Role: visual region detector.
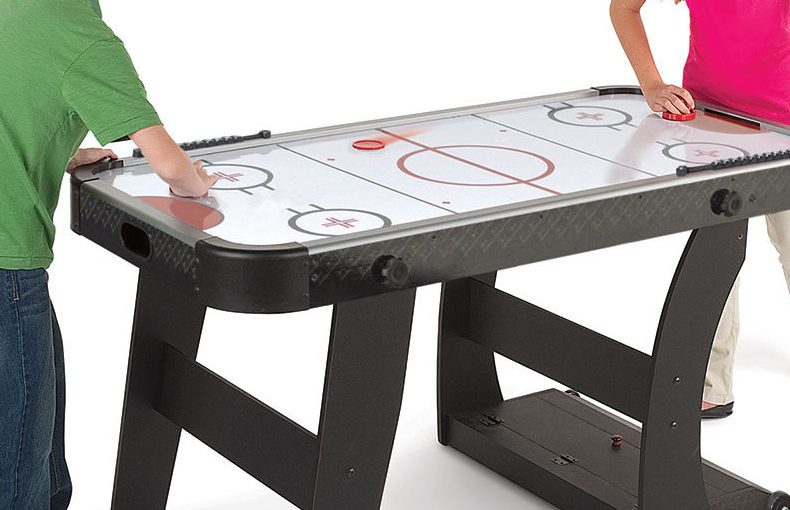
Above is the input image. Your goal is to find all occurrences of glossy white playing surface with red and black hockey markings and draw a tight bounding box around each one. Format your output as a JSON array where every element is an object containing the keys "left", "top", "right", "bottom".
[{"left": 102, "top": 95, "right": 790, "bottom": 249}]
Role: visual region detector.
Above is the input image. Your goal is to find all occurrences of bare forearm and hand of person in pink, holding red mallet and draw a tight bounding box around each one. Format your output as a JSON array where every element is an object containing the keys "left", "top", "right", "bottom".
[{"left": 609, "top": 0, "right": 694, "bottom": 113}]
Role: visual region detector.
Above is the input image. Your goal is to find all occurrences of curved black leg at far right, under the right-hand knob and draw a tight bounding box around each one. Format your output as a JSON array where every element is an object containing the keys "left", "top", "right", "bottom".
[{"left": 639, "top": 220, "right": 748, "bottom": 510}]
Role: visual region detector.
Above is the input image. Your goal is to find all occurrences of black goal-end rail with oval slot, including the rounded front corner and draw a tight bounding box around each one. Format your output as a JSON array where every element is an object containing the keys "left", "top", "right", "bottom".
[{"left": 71, "top": 163, "right": 309, "bottom": 313}]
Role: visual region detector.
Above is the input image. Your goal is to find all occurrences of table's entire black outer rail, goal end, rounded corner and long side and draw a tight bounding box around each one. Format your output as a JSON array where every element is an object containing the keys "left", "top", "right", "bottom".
[{"left": 72, "top": 157, "right": 790, "bottom": 313}]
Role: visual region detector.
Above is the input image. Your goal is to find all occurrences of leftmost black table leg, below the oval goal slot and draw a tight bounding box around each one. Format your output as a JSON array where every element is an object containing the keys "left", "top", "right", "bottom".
[{"left": 112, "top": 271, "right": 206, "bottom": 510}]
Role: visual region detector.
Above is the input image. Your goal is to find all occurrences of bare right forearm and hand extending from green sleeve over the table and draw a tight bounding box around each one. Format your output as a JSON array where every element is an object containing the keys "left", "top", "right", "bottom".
[{"left": 129, "top": 125, "right": 219, "bottom": 197}]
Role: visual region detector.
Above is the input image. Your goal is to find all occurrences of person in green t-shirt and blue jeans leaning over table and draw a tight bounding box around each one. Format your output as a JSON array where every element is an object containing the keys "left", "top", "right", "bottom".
[{"left": 0, "top": 0, "right": 217, "bottom": 504}]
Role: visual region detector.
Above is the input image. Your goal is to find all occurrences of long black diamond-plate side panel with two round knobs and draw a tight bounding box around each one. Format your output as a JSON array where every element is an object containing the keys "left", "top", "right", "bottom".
[{"left": 310, "top": 161, "right": 790, "bottom": 306}]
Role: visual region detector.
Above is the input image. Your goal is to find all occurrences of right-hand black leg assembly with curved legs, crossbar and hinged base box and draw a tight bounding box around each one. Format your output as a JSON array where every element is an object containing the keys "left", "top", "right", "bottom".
[{"left": 439, "top": 220, "right": 769, "bottom": 510}]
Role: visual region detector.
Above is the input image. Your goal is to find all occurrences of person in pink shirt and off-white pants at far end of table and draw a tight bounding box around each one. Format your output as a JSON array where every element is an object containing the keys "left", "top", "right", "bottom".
[{"left": 611, "top": 0, "right": 790, "bottom": 418}]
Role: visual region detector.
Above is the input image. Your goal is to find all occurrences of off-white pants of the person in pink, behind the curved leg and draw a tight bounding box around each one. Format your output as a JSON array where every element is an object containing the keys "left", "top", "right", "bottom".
[{"left": 703, "top": 211, "right": 790, "bottom": 405}]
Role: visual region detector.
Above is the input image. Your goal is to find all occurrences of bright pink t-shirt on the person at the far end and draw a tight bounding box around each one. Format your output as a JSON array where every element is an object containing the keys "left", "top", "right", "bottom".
[{"left": 683, "top": 0, "right": 790, "bottom": 125}]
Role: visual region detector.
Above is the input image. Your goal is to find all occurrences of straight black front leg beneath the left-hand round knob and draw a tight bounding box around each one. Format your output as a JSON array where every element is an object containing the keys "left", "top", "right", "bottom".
[{"left": 311, "top": 290, "right": 415, "bottom": 510}]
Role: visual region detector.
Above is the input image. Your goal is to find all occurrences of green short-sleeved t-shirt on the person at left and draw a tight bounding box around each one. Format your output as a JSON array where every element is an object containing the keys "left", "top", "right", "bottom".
[{"left": 0, "top": 0, "right": 160, "bottom": 269}]
